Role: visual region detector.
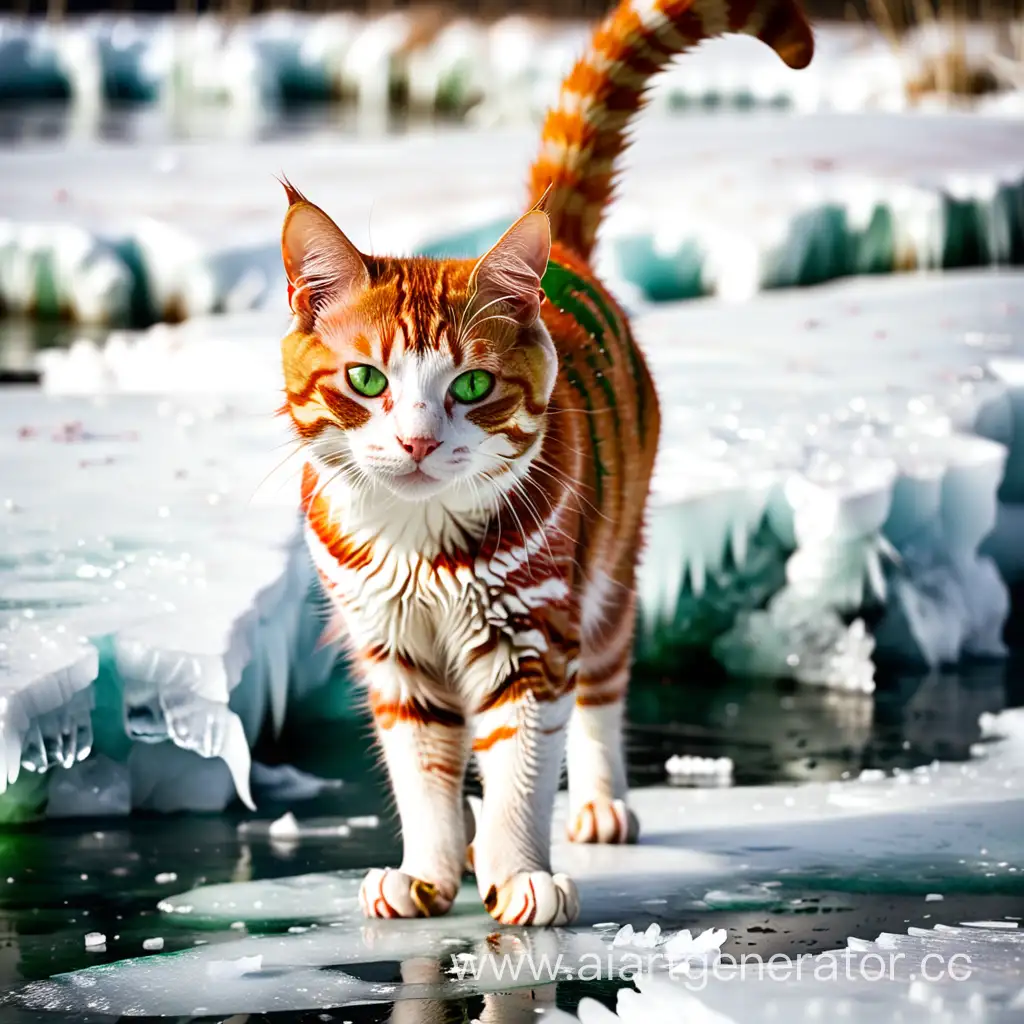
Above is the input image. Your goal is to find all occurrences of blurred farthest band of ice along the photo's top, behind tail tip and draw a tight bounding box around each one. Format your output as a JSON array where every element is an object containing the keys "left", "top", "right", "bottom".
[{"left": 0, "top": 11, "right": 1021, "bottom": 123}]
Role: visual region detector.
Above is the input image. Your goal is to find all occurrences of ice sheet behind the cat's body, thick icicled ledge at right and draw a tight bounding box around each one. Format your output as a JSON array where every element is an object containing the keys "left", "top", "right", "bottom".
[{"left": 36, "top": 271, "right": 1024, "bottom": 690}]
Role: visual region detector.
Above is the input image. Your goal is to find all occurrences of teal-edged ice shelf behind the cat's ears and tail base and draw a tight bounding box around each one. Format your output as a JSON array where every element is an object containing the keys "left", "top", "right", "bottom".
[{"left": 0, "top": 111, "right": 1024, "bottom": 325}]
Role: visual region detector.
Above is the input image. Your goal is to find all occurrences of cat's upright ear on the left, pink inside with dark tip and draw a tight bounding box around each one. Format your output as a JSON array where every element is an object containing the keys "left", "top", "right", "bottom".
[{"left": 281, "top": 180, "right": 370, "bottom": 314}]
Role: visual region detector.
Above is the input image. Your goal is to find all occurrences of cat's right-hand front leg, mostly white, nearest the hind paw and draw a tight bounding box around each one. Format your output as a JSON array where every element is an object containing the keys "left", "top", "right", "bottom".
[{"left": 473, "top": 657, "right": 580, "bottom": 926}]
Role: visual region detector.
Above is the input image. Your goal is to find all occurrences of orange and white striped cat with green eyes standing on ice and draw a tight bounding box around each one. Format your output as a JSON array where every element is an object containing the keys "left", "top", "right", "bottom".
[{"left": 282, "top": 0, "right": 813, "bottom": 926}]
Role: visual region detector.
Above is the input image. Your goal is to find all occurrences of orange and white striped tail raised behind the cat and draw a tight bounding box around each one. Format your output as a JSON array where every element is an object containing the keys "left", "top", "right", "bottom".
[{"left": 529, "top": 0, "right": 814, "bottom": 259}]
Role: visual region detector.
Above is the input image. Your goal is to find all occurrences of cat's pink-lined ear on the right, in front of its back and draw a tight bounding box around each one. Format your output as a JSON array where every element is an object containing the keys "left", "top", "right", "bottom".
[{"left": 470, "top": 209, "right": 551, "bottom": 327}]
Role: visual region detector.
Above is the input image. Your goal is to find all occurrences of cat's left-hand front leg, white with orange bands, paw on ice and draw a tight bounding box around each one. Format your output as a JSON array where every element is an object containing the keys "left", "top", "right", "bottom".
[{"left": 360, "top": 657, "right": 469, "bottom": 918}]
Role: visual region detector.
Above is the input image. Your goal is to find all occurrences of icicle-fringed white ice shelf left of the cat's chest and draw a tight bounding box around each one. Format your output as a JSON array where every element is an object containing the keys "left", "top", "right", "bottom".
[{"left": 0, "top": 376, "right": 330, "bottom": 815}]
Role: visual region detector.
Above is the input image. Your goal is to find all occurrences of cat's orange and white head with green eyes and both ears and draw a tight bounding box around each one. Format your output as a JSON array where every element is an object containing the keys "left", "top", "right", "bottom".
[{"left": 282, "top": 184, "right": 557, "bottom": 501}]
